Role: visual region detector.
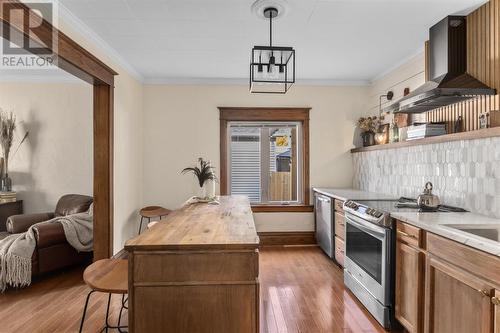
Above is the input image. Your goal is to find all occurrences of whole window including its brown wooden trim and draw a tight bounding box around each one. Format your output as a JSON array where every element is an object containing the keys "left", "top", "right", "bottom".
[{"left": 220, "top": 108, "right": 309, "bottom": 208}]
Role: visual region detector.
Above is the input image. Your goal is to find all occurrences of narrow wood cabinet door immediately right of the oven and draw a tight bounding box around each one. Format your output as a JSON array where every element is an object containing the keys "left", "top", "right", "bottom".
[{"left": 396, "top": 241, "right": 425, "bottom": 333}]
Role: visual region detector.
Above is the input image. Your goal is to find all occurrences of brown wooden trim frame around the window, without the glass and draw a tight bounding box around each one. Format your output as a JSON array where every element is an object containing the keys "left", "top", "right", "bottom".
[{"left": 219, "top": 107, "right": 313, "bottom": 213}]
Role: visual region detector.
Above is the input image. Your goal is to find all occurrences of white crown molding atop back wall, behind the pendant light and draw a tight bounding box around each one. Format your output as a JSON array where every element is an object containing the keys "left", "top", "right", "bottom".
[{"left": 144, "top": 77, "right": 370, "bottom": 86}]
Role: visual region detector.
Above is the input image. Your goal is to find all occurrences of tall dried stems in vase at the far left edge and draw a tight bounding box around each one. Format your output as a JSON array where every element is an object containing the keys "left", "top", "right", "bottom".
[{"left": 0, "top": 109, "right": 28, "bottom": 192}]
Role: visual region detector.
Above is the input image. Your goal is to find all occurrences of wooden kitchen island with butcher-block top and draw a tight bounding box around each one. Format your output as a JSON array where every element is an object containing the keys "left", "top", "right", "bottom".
[{"left": 125, "top": 196, "right": 259, "bottom": 333}]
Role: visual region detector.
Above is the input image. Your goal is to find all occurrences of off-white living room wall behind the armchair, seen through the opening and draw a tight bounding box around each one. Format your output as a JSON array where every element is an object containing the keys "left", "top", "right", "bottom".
[{"left": 0, "top": 82, "right": 93, "bottom": 213}]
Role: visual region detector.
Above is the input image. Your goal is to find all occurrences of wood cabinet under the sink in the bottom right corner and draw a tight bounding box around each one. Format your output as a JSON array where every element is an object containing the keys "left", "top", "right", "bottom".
[{"left": 425, "top": 234, "right": 500, "bottom": 333}]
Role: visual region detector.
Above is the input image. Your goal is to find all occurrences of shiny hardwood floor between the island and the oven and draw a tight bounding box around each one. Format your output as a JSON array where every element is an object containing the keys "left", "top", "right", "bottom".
[{"left": 259, "top": 247, "right": 392, "bottom": 333}]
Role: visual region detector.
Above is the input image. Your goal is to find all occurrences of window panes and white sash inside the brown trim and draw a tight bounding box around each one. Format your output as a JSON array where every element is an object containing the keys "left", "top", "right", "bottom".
[{"left": 228, "top": 121, "right": 302, "bottom": 203}]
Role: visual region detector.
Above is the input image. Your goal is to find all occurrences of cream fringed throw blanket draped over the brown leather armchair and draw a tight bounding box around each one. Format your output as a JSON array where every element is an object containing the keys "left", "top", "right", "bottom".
[{"left": 0, "top": 209, "right": 94, "bottom": 292}]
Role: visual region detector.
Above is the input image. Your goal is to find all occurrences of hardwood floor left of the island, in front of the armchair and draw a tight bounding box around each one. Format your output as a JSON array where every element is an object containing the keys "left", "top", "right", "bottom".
[{"left": 0, "top": 268, "right": 127, "bottom": 333}]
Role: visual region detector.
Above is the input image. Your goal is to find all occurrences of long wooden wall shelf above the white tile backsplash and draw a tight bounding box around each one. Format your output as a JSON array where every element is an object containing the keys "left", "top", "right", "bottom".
[{"left": 351, "top": 127, "right": 500, "bottom": 153}]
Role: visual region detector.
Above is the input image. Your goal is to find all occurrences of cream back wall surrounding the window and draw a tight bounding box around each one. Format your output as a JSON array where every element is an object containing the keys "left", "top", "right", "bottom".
[{"left": 144, "top": 85, "right": 367, "bottom": 231}]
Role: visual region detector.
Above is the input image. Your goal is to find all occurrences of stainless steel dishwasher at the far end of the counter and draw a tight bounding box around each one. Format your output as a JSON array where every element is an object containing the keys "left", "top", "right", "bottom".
[{"left": 314, "top": 193, "right": 335, "bottom": 259}]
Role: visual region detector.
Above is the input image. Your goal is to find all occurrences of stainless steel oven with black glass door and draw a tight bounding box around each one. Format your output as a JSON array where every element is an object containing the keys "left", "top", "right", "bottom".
[{"left": 344, "top": 201, "right": 395, "bottom": 328}]
